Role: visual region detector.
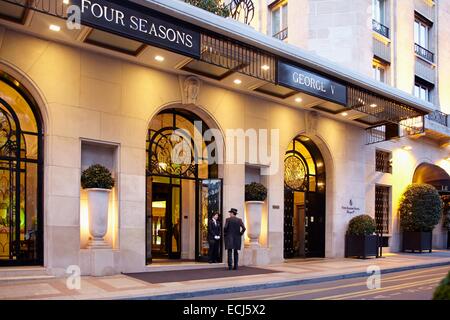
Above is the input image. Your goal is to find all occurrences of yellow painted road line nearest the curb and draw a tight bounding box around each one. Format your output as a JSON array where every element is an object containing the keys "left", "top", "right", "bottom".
[{"left": 228, "top": 266, "right": 449, "bottom": 300}]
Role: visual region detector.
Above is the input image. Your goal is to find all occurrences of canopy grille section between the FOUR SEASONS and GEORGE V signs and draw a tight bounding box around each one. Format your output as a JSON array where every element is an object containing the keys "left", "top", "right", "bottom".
[{"left": 200, "top": 34, "right": 276, "bottom": 83}]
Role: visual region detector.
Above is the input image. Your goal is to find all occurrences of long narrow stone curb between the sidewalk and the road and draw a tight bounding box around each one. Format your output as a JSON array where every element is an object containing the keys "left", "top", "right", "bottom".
[{"left": 124, "top": 261, "right": 450, "bottom": 300}]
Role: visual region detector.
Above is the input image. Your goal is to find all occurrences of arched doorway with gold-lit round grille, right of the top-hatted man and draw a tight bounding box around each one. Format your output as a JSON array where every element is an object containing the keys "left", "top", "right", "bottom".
[{"left": 284, "top": 136, "right": 325, "bottom": 259}]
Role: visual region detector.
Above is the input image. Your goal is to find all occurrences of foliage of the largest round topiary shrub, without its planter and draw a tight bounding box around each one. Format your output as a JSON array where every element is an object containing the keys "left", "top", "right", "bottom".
[{"left": 398, "top": 183, "right": 443, "bottom": 232}]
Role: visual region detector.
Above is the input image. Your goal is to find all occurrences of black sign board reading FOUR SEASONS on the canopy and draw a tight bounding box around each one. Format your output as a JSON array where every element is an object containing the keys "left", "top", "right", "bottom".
[{"left": 73, "top": 0, "right": 200, "bottom": 59}]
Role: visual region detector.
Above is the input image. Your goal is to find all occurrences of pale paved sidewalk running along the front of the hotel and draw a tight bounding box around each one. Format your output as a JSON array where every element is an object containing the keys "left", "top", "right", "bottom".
[{"left": 0, "top": 251, "right": 450, "bottom": 300}]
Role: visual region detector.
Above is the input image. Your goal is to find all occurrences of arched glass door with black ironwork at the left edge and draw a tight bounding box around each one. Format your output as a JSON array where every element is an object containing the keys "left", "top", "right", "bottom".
[{"left": 0, "top": 72, "right": 43, "bottom": 265}]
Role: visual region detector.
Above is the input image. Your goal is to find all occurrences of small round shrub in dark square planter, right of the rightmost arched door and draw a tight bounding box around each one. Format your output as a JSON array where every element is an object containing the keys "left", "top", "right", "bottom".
[{"left": 345, "top": 214, "right": 378, "bottom": 259}]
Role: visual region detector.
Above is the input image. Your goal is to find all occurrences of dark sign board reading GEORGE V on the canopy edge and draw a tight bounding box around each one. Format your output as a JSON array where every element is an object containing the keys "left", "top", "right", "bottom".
[{"left": 278, "top": 61, "right": 347, "bottom": 106}]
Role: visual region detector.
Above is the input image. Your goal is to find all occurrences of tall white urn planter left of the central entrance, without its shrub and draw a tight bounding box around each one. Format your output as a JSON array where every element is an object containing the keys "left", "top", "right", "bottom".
[{"left": 86, "top": 189, "right": 111, "bottom": 249}]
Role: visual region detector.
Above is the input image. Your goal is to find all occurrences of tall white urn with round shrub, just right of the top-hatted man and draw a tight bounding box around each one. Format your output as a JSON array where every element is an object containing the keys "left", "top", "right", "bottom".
[{"left": 245, "top": 182, "right": 267, "bottom": 246}]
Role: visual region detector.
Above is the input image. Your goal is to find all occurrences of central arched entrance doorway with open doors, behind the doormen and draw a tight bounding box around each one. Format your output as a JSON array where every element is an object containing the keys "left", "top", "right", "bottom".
[{"left": 146, "top": 109, "right": 222, "bottom": 263}]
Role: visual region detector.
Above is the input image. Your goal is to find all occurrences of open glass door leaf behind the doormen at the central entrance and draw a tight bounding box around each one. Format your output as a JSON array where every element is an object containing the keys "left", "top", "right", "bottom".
[{"left": 195, "top": 179, "right": 223, "bottom": 262}]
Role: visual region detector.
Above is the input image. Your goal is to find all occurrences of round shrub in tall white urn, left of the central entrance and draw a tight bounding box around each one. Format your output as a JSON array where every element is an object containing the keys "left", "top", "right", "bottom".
[{"left": 81, "top": 164, "right": 114, "bottom": 248}]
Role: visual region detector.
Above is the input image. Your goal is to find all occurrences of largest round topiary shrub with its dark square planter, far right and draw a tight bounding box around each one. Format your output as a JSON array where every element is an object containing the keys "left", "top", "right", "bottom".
[{"left": 398, "top": 183, "right": 443, "bottom": 252}]
